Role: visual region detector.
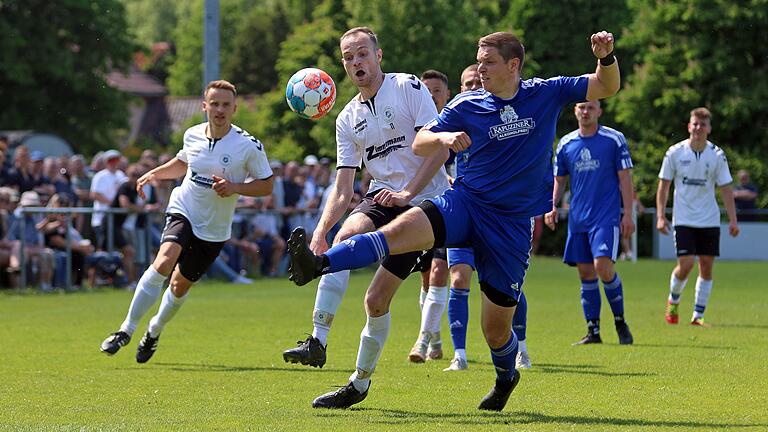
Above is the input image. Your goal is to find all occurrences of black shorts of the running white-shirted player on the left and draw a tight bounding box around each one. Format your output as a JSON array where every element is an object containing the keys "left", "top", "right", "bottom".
[{"left": 160, "top": 213, "right": 226, "bottom": 282}]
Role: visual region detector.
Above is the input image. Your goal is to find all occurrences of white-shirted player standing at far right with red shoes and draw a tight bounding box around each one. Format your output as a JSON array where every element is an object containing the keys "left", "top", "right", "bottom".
[{"left": 656, "top": 108, "right": 739, "bottom": 326}]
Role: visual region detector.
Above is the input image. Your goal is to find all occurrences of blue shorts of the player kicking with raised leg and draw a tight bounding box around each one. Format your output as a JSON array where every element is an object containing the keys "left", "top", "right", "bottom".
[{"left": 430, "top": 189, "right": 533, "bottom": 302}]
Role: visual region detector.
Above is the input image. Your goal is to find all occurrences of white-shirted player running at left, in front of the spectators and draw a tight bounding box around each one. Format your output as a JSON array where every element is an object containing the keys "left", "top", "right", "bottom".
[{"left": 101, "top": 80, "right": 273, "bottom": 363}]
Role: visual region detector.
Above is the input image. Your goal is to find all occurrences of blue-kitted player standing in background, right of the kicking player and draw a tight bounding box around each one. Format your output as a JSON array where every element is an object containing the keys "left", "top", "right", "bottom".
[{"left": 544, "top": 101, "right": 635, "bottom": 345}]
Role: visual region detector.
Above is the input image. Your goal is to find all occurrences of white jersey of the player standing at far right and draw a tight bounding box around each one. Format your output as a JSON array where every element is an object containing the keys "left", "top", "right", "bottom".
[{"left": 659, "top": 139, "right": 733, "bottom": 228}]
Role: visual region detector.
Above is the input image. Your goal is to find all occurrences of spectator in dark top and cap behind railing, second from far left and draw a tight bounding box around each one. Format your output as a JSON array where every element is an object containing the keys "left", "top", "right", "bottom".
[{"left": 41, "top": 194, "right": 95, "bottom": 288}]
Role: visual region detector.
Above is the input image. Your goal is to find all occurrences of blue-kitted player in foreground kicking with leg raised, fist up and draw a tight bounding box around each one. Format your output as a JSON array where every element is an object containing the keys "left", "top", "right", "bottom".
[{"left": 288, "top": 32, "right": 620, "bottom": 411}]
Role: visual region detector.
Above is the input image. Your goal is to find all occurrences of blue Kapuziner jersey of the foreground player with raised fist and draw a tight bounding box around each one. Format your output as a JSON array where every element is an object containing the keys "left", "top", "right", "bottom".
[{"left": 425, "top": 76, "right": 588, "bottom": 217}]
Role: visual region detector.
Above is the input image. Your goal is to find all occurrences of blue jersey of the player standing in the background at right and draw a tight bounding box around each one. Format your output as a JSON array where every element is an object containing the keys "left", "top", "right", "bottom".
[{"left": 555, "top": 125, "right": 632, "bottom": 232}]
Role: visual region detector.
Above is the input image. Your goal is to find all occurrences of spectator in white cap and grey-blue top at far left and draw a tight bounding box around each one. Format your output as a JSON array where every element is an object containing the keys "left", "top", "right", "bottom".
[{"left": 8, "top": 191, "right": 54, "bottom": 292}]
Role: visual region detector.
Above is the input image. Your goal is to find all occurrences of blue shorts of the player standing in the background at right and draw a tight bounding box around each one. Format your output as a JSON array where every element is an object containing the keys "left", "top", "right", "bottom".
[{"left": 563, "top": 226, "right": 619, "bottom": 265}]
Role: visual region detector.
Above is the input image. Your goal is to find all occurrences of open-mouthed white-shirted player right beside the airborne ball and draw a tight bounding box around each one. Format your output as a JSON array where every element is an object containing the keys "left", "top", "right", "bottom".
[{"left": 283, "top": 27, "right": 448, "bottom": 407}]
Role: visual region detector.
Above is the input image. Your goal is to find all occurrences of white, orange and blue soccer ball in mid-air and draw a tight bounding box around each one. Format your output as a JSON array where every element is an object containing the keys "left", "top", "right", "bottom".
[{"left": 285, "top": 68, "right": 336, "bottom": 120}]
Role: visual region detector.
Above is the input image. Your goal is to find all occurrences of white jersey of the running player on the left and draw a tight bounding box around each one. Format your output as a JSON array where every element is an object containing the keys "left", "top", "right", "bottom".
[{"left": 166, "top": 123, "right": 272, "bottom": 242}]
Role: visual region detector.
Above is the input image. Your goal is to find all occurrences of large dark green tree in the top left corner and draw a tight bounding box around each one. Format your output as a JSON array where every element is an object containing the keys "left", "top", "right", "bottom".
[{"left": 0, "top": 0, "right": 135, "bottom": 153}]
